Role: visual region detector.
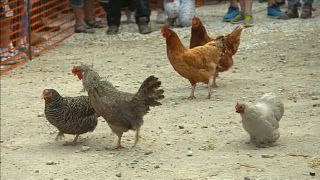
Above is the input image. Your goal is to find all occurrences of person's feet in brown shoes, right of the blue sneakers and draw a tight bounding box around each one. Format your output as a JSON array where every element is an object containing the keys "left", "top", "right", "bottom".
[{"left": 286, "top": 0, "right": 313, "bottom": 19}]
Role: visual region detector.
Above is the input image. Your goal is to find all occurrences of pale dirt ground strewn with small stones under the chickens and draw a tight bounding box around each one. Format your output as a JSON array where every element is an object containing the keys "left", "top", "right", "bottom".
[{"left": 1, "top": 1, "right": 320, "bottom": 180}]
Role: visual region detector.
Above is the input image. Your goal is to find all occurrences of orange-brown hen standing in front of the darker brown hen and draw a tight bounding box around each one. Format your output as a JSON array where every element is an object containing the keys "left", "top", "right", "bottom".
[{"left": 161, "top": 26, "right": 222, "bottom": 99}]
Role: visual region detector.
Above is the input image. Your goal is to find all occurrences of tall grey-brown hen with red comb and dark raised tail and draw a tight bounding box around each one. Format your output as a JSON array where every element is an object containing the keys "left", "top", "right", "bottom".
[{"left": 72, "top": 65, "right": 164, "bottom": 149}]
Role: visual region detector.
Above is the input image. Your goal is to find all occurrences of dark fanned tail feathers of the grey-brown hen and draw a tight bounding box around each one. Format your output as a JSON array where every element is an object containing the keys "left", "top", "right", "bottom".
[{"left": 137, "top": 76, "right": 164, "bottom": 106}]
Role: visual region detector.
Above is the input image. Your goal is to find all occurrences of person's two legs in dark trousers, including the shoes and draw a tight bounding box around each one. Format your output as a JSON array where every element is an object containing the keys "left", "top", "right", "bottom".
[{"left": 100, "top": 0, "right": 151, "bottom": 35}]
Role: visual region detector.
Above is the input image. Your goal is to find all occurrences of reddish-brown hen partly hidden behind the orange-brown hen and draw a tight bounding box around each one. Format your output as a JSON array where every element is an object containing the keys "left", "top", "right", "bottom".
[{"left": 190, "top": 16, "right": 243, "bottom": 74}]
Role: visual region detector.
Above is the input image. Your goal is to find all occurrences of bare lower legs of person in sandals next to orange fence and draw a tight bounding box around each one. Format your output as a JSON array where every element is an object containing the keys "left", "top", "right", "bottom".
[{"left": 70, "top": 0, "right": 104, "bottom": 33}]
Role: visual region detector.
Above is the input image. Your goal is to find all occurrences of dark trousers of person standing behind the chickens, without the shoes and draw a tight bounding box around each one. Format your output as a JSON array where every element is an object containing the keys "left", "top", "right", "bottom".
[{"left": 100, "top": 0, "right": 151, "bottom": 27}]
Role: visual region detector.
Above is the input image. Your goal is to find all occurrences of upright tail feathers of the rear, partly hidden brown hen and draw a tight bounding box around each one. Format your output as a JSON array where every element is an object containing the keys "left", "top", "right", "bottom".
[{"left": 224, "top": 26, "right": 243, "bottom": 55}]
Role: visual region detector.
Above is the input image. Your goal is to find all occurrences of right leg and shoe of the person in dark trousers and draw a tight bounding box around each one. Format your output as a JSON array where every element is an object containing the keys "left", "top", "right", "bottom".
[{"left": 135, "top": 0, "right": 151, "bottom": 34}]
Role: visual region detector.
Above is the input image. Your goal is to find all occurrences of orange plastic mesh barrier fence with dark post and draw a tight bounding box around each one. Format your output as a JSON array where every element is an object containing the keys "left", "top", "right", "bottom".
[{"left": 0, "top": 0, "right": 203, "bottom": 75}]
